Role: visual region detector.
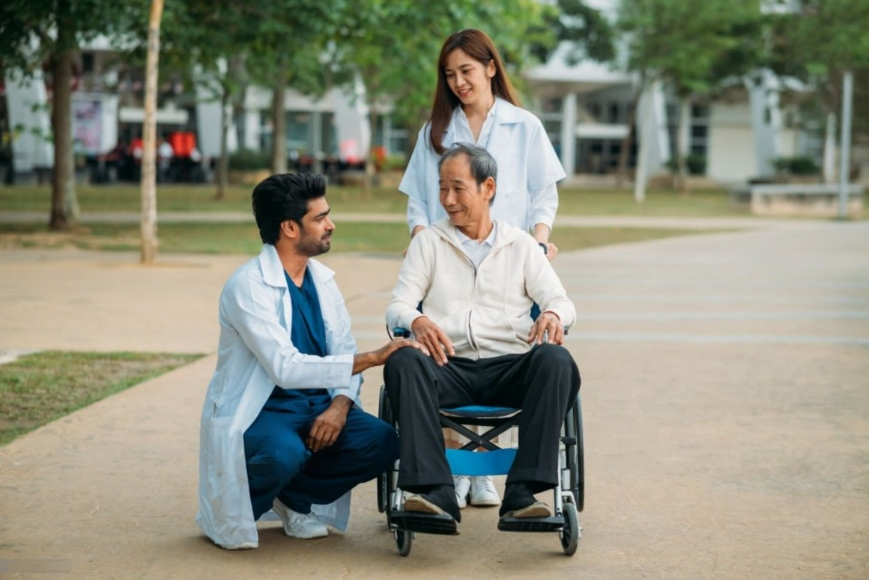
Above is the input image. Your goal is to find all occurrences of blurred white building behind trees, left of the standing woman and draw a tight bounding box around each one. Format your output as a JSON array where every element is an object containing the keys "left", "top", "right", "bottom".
[{"left": 3, "top": 38, "right": 392, "bottom": 176}]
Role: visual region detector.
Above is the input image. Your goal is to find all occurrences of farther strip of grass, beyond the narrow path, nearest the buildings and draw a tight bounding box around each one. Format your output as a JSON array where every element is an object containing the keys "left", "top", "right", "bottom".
[{"left": 0, "top": 185, "right": 768, "bottom": 220}]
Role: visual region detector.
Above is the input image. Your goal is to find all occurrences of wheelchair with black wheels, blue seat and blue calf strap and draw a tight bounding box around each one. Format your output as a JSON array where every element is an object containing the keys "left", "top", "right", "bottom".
[{"left": 377, "top": 376, "right": 585, "bottom": 556}]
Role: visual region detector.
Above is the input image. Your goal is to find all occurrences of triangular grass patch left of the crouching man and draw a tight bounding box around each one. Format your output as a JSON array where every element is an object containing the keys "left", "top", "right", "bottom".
[{"left": 0, "top": 351, "right": 203, "bottom": 445}]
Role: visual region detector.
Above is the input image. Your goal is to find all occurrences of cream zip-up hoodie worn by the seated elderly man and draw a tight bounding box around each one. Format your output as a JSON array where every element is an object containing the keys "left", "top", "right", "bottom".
[{"left": 386, "top": 218, "right": 576, "bottom": 359}]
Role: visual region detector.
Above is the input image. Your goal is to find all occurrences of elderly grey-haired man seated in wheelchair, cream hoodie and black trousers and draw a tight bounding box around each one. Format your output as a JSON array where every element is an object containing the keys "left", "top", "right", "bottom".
[{"left": 384, "top": 144, "right": 580, "bottom": 549}]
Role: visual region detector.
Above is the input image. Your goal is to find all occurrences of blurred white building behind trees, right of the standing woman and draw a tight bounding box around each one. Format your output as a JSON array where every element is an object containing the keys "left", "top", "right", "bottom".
[{"left": 525, "top": 0, "right": 824, "bottom": 184}]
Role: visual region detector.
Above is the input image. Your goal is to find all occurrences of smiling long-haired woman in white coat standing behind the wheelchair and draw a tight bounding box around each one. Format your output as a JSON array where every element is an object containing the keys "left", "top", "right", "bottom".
[{"left": 398, "top": 29, "right": 565, "bottom": 507}]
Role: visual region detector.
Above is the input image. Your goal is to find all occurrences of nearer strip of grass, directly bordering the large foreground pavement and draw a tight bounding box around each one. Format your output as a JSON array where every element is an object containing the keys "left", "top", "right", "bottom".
[{"left": 0, "top": 223, "right": 724, "bottom": 255}]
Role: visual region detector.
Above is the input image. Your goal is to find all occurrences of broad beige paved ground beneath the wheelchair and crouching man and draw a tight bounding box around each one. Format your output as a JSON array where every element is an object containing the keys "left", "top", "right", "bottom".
[{"left": 0, "top": 221, "right": 869, "bottom": 580}]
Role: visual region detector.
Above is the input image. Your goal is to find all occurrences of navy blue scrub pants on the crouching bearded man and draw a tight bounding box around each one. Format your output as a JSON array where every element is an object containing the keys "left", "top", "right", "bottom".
[{"left": 244, "top": 391, "right": 398, "bottom": 520}]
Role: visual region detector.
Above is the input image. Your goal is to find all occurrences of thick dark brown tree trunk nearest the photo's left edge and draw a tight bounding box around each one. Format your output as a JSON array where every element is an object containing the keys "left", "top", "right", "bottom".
[{"left": 48, "top": 43, "right": 79, "bottom": 230}]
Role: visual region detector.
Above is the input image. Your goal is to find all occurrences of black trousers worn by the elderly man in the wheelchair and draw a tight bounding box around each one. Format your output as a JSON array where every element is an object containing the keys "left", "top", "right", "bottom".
[{"left": 383, "top": 344, "right": 580, "bottom": 493}]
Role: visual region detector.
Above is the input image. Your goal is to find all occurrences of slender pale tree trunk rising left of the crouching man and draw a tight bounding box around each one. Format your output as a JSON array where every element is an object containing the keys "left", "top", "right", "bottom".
[{"left": 141, "top": 0, "right": 163, "bottom": 264}]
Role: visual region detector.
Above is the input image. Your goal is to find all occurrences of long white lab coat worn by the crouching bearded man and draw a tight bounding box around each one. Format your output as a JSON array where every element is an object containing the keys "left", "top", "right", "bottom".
[{"left": 196, "top": 244, "right": 362, "bottom": 548}]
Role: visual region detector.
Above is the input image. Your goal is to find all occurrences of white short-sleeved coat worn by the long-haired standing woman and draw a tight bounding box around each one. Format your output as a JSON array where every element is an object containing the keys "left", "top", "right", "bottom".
[{"left": 398, "top": 98, "right": 566, "bottom": 232}]
